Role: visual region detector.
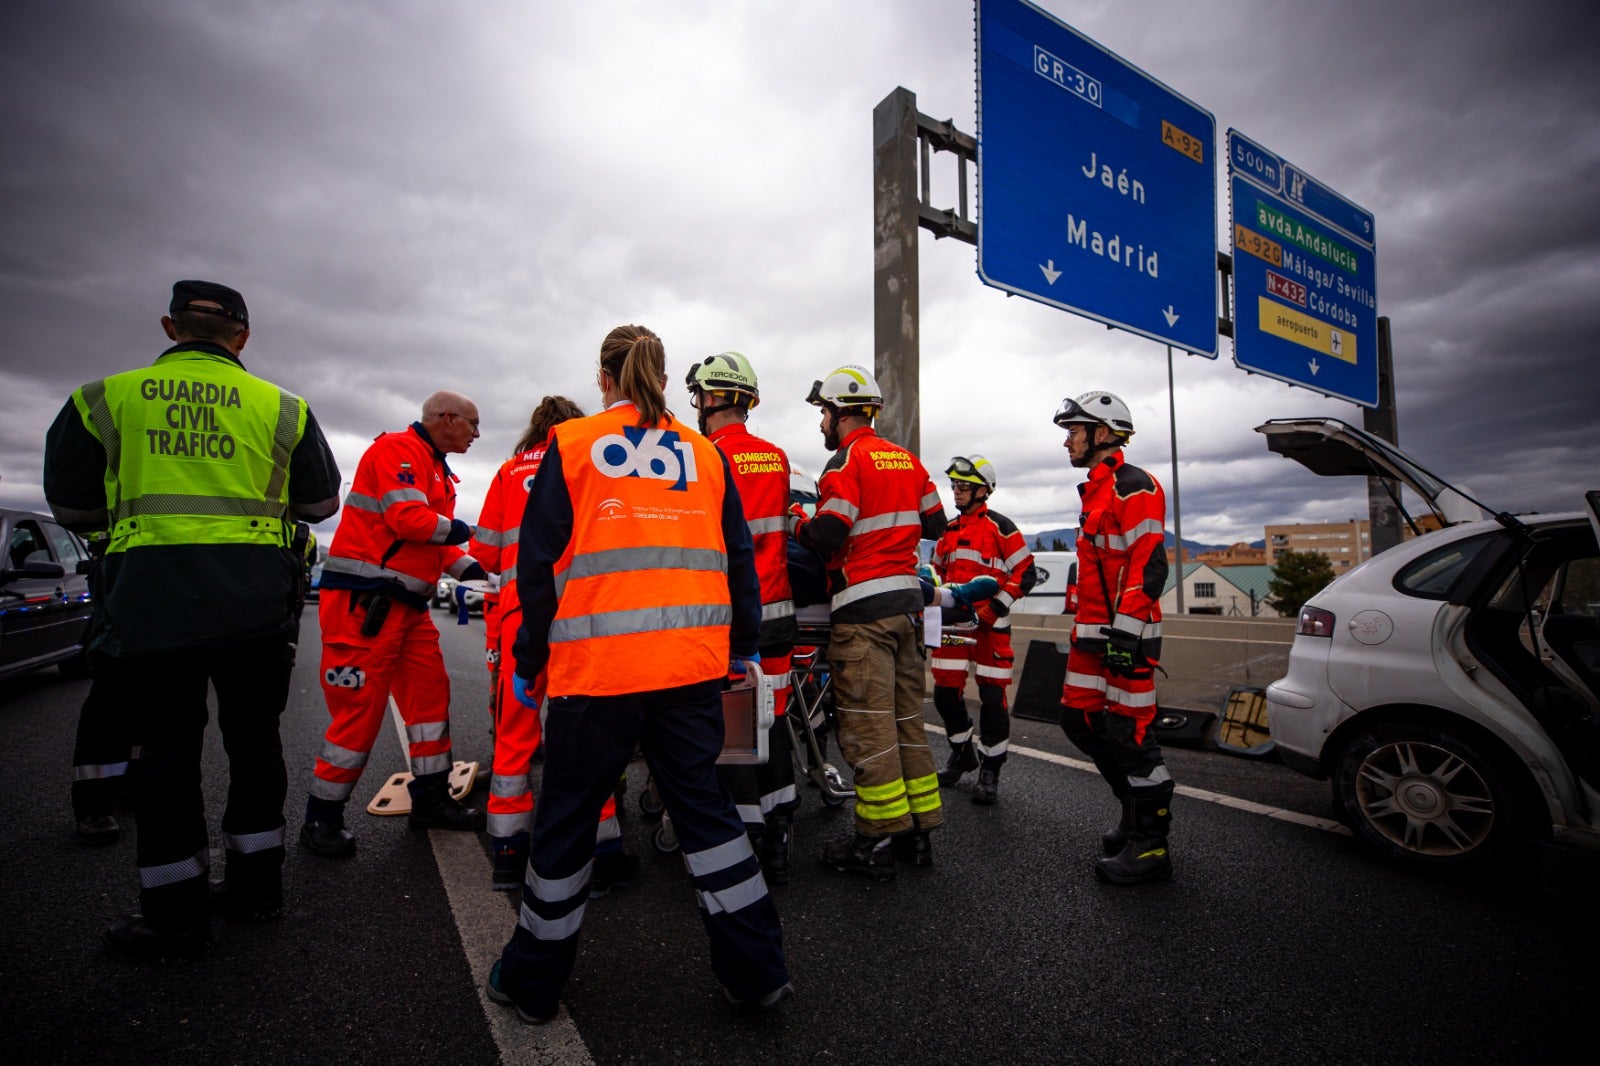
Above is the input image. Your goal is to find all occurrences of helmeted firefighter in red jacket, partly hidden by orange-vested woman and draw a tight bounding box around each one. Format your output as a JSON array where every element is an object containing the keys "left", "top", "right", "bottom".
[{"left": 686, "top": 352, "right": 800, "bottom": 885}]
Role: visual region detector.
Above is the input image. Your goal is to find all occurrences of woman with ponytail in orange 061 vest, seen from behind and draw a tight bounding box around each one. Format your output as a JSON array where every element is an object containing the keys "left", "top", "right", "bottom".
[{"left": 488, "top": 325, "right": 790, "bottom": 1024}]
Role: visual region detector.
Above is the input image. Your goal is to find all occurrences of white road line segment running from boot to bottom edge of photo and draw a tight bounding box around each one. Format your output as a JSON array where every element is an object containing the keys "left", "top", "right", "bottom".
[{"left": 427, "top": 829, "right": 595, "bottom": 1066}]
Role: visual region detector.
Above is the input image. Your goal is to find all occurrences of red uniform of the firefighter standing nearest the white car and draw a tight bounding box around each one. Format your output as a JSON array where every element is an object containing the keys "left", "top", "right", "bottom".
[{"left": 1061, "top": 448, "right": 1171, "bottom": 795}]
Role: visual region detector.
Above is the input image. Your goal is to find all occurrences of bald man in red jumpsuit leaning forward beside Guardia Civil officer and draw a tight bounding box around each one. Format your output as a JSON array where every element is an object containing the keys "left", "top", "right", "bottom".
[{"left": 301, "top": 392, "right": 488, "bottom": 858}]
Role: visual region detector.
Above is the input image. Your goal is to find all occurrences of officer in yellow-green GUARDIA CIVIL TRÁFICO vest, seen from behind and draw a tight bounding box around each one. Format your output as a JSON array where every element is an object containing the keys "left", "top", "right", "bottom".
[{"left": 45, "top": 282, "right": 339, "bottom": 959}]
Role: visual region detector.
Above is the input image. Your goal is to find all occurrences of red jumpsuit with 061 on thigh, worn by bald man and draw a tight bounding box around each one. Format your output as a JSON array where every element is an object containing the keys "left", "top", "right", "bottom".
[{"left": 310, "top": 423, "right": 474, "bottom": 802}]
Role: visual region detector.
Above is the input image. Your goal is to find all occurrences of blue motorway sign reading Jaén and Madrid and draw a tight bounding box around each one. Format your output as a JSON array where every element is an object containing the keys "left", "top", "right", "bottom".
[{"left": 978, "top": 0, "right": 1218, "bottom": 359}]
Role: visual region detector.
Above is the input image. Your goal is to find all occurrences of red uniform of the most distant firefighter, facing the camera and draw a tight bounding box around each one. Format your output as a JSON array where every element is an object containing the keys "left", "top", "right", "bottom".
[{"left": 930, "top": 503, "right": 1034, "bottom": 765}]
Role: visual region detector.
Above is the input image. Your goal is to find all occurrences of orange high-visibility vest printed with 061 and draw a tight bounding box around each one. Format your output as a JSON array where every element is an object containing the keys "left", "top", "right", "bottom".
[{"left": 547, "top": 405, "right": 733, "bottom": 696}]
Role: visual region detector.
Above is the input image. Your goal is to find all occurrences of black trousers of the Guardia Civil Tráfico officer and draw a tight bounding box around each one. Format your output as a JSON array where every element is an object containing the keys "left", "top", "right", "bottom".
[{"left": 120, "top": 637, "right": 293, "bottom": 930}]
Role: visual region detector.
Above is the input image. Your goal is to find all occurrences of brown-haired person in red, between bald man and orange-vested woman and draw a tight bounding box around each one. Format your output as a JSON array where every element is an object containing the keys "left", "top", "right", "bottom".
[{"left": 467, "top": 395, "right": 638, "bottom": 898}]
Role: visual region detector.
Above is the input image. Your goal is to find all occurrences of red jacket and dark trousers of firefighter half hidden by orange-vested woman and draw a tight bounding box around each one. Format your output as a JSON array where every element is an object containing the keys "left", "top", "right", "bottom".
[{"left": 709, "top": 423, "right": 800, "bottom": 829}]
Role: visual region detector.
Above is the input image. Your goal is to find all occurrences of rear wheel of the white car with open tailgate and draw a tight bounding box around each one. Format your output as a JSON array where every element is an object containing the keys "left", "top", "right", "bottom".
[{"left": 1333, "top": 725, "right": 1515, "bottom": 869}]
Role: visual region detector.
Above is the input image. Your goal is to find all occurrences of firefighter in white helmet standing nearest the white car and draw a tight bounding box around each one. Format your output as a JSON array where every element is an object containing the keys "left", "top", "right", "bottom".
[{"left": 1056, "top": 392, "right": 1173, "bottom": 885}]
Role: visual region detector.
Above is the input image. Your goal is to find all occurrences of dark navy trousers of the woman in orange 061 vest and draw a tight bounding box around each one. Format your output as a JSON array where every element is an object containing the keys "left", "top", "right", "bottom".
[{"left": 501, "top": 679, "right": 789, "bottom": 1015}]
